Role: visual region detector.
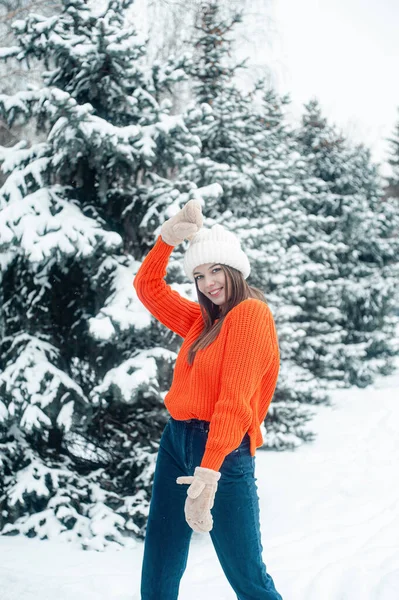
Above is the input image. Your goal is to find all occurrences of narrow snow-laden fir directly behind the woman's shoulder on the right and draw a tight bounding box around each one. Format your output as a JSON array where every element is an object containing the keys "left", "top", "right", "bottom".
[{"left": 236, "top": 85, "right": 334, "bottom": 449}]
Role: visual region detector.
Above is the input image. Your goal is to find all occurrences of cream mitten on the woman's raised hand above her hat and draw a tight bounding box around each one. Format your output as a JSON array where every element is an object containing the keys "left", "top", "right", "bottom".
[{"left": 161, "top": 200, "right": 203, "bottom": 246}]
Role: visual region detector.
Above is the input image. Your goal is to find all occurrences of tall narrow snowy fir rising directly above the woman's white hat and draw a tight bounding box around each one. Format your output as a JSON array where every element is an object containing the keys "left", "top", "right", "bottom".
[{"left": 186, "top": 0, "right": 268, "bottom": 220}]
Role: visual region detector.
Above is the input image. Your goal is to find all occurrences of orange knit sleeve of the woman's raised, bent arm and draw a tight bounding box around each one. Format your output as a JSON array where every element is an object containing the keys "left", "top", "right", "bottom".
[{"left": 133, "top": 236, "right": 201, "bottom": 338}]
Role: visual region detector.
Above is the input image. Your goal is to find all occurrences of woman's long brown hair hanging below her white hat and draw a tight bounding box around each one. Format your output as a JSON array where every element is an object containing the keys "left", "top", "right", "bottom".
[{"left": 187, "top": 263, "right": 267, "bottom": 365}]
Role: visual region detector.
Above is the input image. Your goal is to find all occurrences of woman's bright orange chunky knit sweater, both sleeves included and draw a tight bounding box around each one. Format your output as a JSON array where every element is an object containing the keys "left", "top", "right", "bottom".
[{"left": 133, "top": 236, "right": 280, "bottom": 471}]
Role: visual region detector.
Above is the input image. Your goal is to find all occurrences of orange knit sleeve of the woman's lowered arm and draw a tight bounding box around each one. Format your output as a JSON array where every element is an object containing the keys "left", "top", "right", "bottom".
[{"left": 201, "top": 299, "right": 280, "bottom": 471}]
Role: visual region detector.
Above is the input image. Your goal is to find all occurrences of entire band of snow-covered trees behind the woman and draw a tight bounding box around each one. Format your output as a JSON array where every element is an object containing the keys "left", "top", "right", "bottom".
[{"left": 0, "top": 0, "right": 399, "bottom": 576}]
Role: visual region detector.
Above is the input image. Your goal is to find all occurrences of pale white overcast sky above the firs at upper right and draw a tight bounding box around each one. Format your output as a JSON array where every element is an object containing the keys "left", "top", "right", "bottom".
[{"left": 258, "top": 0, "right": 399, "bottom": 172}]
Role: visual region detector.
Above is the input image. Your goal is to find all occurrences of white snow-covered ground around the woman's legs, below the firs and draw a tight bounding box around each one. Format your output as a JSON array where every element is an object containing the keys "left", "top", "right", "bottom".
[{"left": 0, "top": 360, "right": 399, "bottom": 600}]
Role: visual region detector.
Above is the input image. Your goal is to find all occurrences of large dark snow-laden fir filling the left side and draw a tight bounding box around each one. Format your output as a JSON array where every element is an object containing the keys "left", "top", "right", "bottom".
[{"left": 0, "top": 0, "right": 203, "bottom": 549}]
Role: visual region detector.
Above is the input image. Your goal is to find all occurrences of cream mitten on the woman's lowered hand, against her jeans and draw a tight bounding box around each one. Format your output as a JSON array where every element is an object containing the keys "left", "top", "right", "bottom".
[{"left": 176, "top": 467, "right": 221, "bottom": 533}]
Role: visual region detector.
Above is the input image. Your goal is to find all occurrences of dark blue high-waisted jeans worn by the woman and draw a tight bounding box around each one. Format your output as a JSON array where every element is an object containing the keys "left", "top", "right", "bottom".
[{"left": 141, "top": 418, "right": 282, "bottom": 600}]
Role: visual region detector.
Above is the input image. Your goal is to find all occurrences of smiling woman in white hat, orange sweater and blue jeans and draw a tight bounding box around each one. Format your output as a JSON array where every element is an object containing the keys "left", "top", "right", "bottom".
[{"left": 134, "top": 200, "right": 282, "bottom": 600}]
